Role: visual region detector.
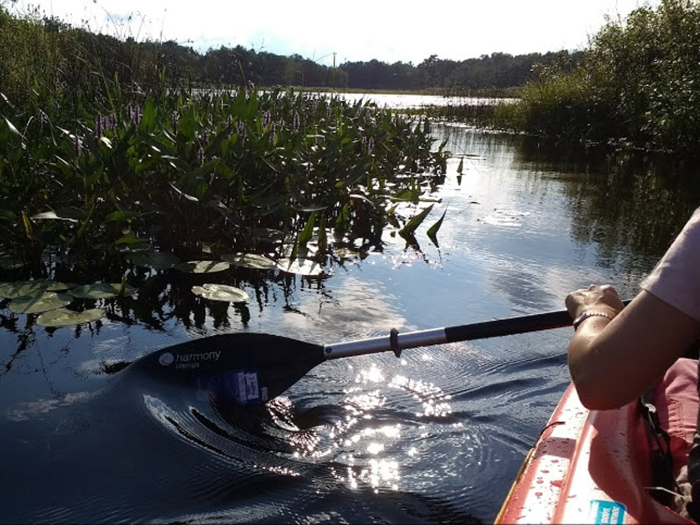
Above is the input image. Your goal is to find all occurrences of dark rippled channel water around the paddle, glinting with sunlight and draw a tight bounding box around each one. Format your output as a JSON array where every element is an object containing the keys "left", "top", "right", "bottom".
[{"left": 0, "top": 127, "right": 700, "bottom": 523}]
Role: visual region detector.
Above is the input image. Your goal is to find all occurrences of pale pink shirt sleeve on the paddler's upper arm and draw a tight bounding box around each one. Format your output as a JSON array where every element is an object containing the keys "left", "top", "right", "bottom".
[{"left": 641, "top": 208, "right": 700, "bottom": 321}]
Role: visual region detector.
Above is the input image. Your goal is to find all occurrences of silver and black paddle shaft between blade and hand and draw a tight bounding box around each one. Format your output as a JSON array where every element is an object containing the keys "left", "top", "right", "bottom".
[{"left": 323, "top": 300, "right": 630, "bottom": 359}]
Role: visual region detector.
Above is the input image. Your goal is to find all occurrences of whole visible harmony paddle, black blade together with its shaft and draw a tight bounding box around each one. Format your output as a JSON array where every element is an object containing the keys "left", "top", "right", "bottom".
[{"left": 129, "top": 301, "right": 629, "bottom": 406}]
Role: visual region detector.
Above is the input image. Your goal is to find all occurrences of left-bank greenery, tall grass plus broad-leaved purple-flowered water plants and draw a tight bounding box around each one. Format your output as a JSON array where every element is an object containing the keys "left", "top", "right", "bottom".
[{"left": 0, "top": 4, "right": 449, "bottom": 288}]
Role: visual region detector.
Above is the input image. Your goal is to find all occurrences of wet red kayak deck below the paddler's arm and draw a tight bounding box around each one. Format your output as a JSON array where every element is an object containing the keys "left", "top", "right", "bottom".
[{"left": 496, "top": 362, "right": 695, "bottom": 523}]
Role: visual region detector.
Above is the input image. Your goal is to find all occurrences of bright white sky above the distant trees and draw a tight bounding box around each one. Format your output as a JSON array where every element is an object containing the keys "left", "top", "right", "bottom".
[{"left": 9, "top": 0, "right": 660, "bottom": 65}]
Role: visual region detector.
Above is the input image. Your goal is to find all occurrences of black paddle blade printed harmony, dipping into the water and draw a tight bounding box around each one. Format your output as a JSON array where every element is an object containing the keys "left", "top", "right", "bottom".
[{"left": 128, "top": 333, "right": 324, "bottom": 406}]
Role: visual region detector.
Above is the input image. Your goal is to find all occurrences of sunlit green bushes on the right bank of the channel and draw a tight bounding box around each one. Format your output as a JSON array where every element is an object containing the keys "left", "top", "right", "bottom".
[{"left": 496, "top": 0, "right": 700, "bottom": 157}]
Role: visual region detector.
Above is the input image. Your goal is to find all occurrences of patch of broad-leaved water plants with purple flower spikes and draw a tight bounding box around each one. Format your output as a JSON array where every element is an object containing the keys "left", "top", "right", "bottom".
[{"left": 0, "top": 89, "right": 448, "bottom": 278}]
